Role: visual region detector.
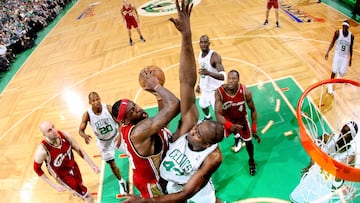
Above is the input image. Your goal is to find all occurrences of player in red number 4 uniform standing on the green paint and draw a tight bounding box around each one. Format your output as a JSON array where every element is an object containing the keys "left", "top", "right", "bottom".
[{"left": 215, "top": 70, "right": 261, "bottom": 176}]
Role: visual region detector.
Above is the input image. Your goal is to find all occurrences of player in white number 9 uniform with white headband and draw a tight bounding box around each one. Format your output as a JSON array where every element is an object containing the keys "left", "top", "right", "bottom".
[{"left": 325, "top": 20, "right": 355, "bottom": 94}]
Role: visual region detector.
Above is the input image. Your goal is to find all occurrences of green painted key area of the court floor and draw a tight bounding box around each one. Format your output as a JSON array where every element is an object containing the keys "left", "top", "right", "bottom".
[{"left": 98, "top": 77, "right": 360, "bottom": 203}]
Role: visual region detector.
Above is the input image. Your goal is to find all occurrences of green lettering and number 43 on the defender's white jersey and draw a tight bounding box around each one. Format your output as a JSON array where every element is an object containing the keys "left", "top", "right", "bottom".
[{"left": 163, "top": 149, "right": 192, "bottom": 176}]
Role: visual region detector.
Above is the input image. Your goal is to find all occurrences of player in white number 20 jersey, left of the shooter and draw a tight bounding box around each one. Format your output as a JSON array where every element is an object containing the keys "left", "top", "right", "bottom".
[{"left": 79, "top": 92, "right": 128, "bottom": 195}]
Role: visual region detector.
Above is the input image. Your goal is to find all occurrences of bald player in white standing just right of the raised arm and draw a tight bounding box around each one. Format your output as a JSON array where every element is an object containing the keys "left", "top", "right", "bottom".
[{"left": 196, "top": 35, "right": 226, "bottom": 120}]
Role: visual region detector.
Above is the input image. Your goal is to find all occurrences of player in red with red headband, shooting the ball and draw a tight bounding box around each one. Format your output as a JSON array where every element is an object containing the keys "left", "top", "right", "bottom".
[{"left": 112, "top": 69, "right": 180, "bottom": 198}]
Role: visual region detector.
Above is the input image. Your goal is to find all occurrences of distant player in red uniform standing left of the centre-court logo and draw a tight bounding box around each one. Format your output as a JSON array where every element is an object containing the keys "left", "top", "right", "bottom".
[{"left": 121, "top": 0, "right": 145, "bottom": 46}]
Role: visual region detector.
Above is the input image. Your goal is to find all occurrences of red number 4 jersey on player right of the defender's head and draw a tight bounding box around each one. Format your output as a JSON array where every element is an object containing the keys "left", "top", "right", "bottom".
[{"left": 218, "top": 84, "right": 247, "bottom": 124}]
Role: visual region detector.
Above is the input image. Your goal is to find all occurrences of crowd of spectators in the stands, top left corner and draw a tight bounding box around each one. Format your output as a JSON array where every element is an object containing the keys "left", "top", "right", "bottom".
[{"left": 0, "top": 0, "right": 71, "bottom": 72}]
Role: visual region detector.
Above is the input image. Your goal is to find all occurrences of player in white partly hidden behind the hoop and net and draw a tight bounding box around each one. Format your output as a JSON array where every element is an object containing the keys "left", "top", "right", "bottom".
[{"left": 290, "top": 121, "right": 360, "bottom": 203}]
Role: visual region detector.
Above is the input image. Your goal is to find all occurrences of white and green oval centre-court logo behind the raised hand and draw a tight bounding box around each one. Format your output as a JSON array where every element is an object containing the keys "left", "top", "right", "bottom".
[{"left": 137, "top": 0, "right": 201, "bottom": 16}]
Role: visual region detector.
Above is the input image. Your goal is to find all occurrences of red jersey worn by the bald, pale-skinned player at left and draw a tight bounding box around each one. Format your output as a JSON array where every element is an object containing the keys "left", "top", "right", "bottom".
[{"left": 41, "top": 131, "right": 75, "bottom": 177}]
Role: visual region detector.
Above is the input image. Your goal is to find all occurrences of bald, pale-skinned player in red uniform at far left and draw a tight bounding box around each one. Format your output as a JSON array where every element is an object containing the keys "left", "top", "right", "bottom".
[{"left": 34, "top": 121, "right": 100, "bottom": 202}]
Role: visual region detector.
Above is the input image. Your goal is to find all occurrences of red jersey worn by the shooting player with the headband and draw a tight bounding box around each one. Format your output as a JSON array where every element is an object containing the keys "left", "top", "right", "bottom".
[{"left": 121, "top": 125, "right": 171, "bottom": 198}]
